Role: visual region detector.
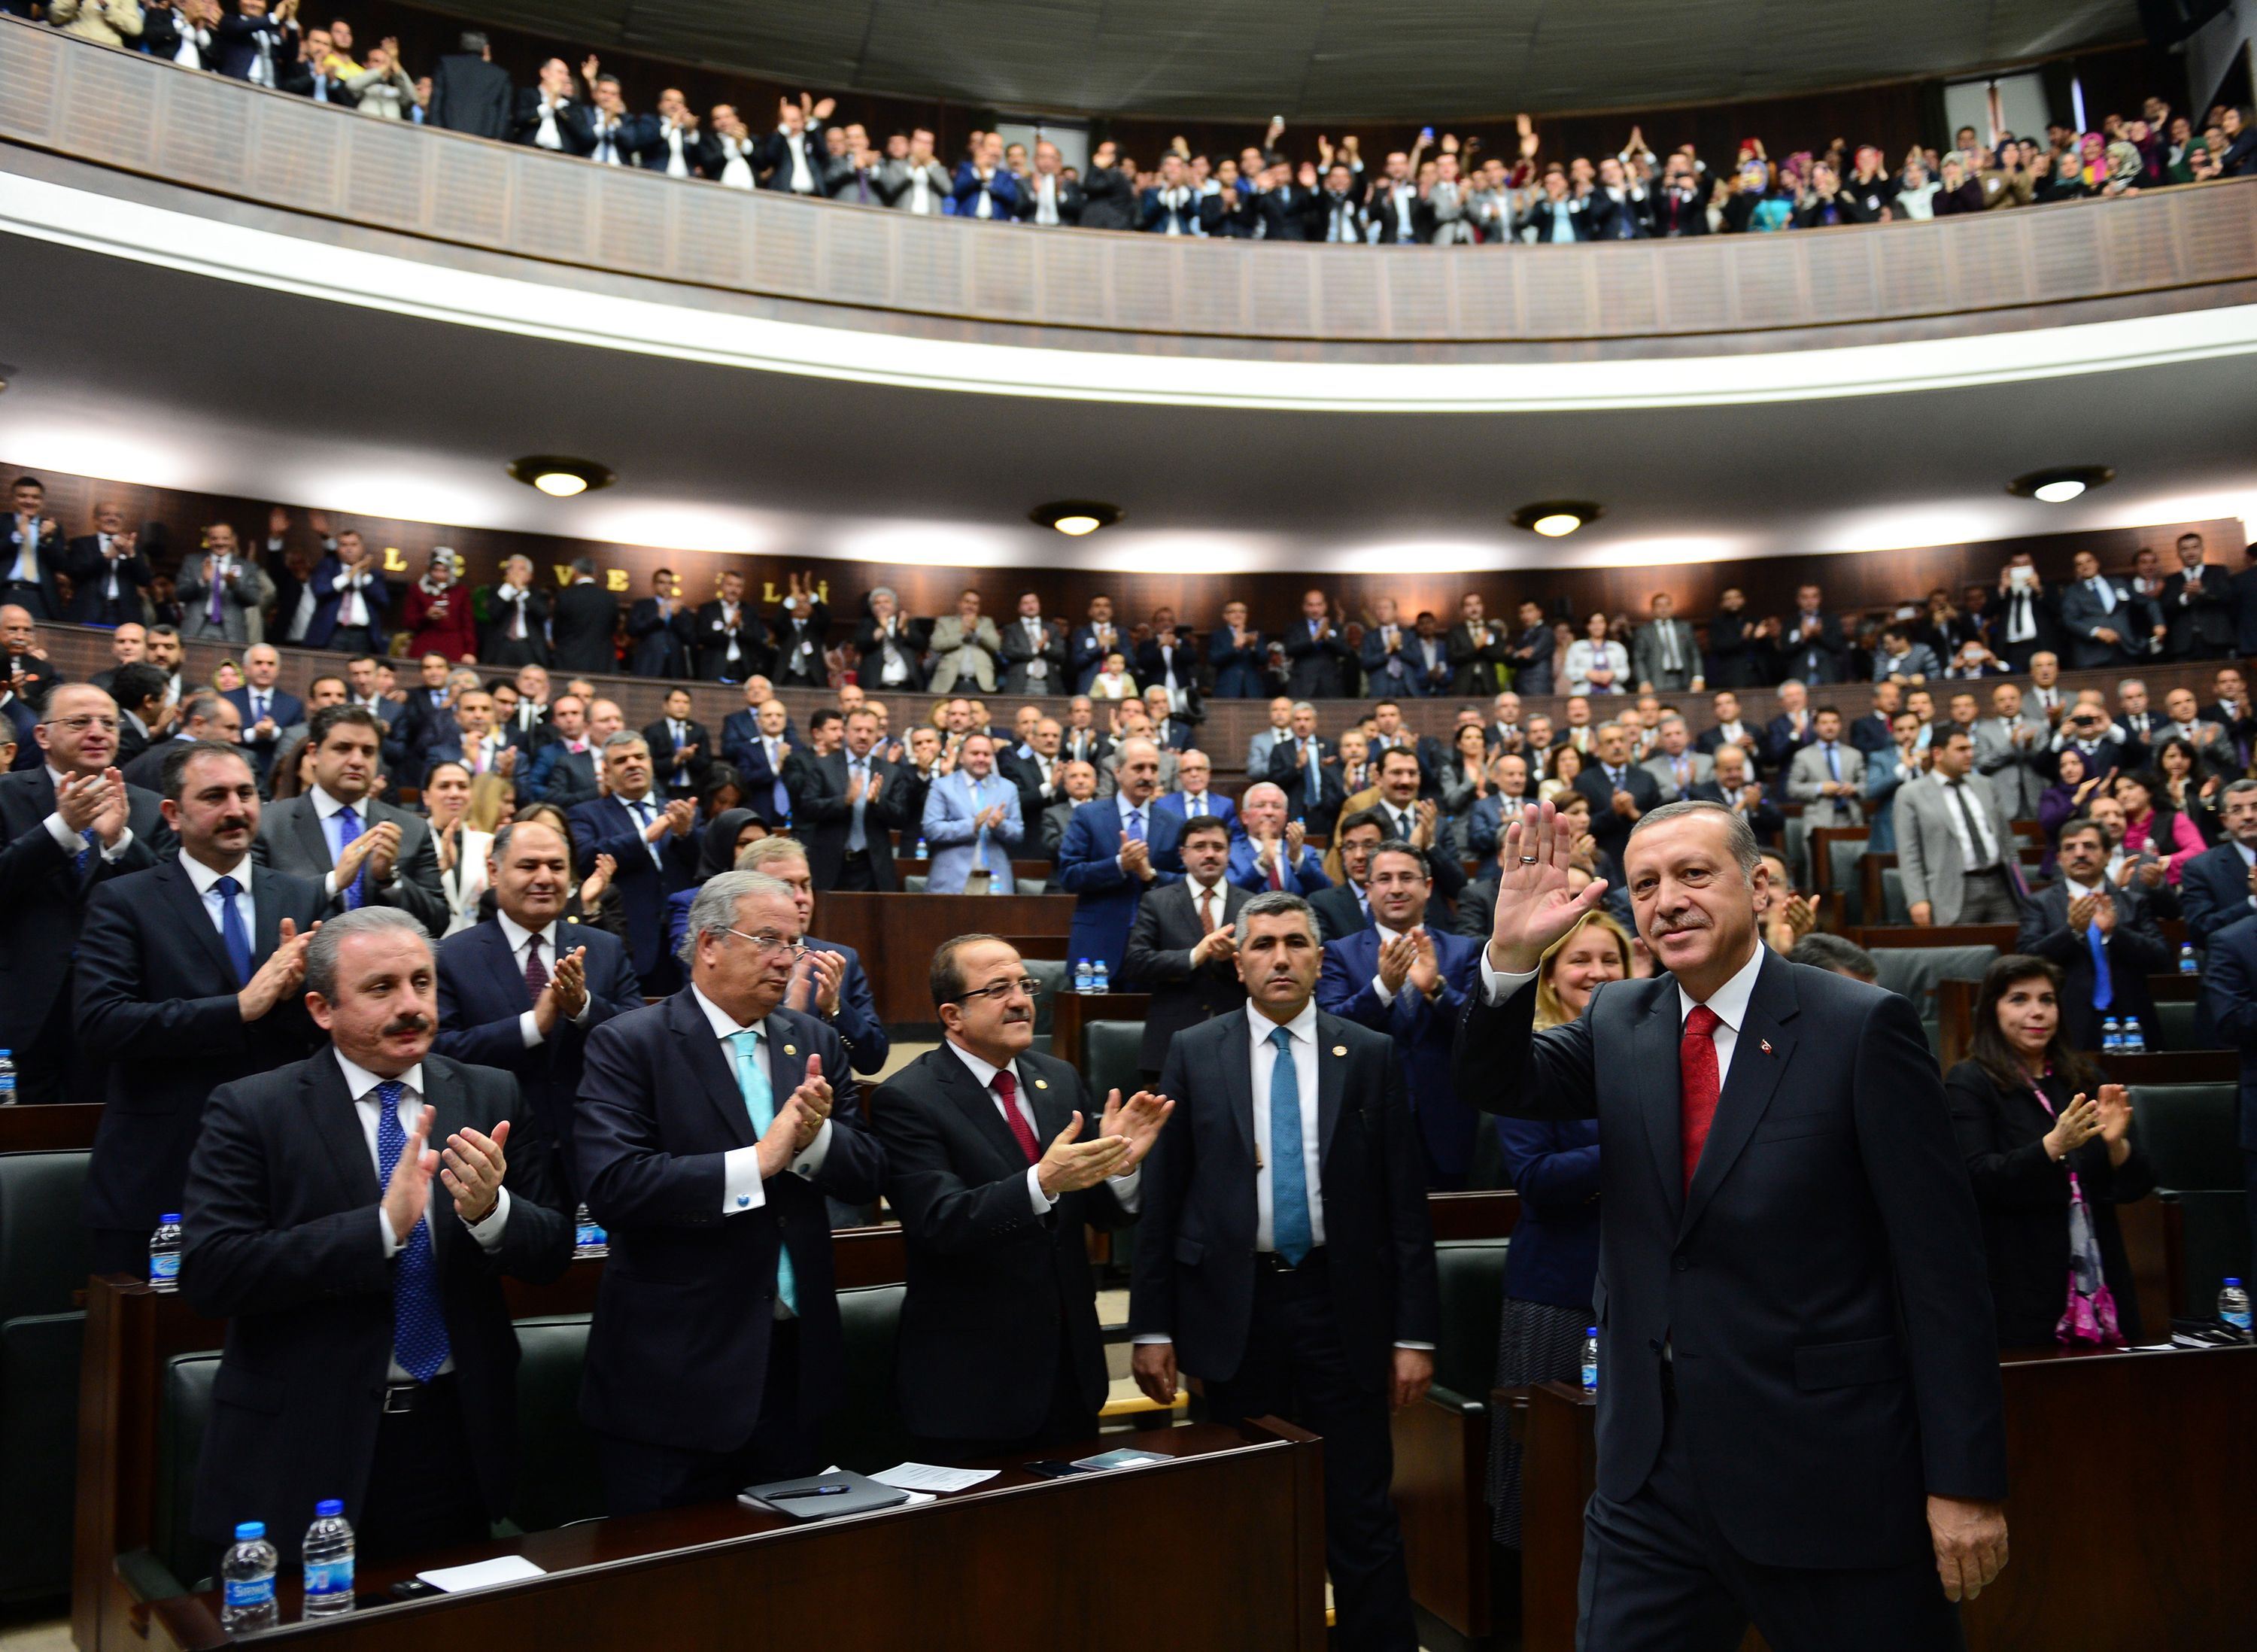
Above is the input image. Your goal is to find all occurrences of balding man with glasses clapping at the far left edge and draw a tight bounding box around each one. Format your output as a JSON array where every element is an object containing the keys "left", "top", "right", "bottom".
[{"left": 0, "top": 682, "right": 172, "bottom": 1101}]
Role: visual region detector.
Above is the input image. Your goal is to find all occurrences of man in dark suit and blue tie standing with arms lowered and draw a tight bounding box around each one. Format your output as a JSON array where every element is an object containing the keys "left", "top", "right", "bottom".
[{"left": 1128, "top": 891, "right": 1442, "bottom": 1652}]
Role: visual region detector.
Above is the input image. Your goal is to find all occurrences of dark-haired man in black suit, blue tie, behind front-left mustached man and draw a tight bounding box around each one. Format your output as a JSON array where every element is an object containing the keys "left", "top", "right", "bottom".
[{"left": 77, "top": 740, "right": 332, "bottom": 1275}]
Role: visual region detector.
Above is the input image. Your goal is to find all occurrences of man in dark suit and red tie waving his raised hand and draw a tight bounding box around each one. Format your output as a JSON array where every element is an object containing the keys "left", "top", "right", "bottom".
[{"left": 1463, "top": 801, "right": 2006, "bottom": 1652}]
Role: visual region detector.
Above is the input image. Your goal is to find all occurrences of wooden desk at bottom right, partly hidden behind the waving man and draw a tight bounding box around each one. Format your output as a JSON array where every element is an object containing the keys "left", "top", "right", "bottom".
[{"left": 1521, "top": 1347, "right": 2257, "bottom": 1652}]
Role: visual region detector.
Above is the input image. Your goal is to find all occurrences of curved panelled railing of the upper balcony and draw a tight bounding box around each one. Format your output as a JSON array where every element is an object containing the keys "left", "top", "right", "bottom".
[{"left": 0, "top": 18, "right": 2257, "bottom": 354}]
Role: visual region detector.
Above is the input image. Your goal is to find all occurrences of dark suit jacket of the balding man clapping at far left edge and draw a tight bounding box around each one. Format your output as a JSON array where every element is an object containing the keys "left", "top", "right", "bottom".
[{"left": 0, "top": 763, "right": 176, "bottom": 1061}]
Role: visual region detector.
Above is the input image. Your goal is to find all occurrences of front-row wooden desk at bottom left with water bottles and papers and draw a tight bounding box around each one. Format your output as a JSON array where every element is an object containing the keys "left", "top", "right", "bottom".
[{"left": 144, "top": 1420, "right": 1325, "bottom": 1652}]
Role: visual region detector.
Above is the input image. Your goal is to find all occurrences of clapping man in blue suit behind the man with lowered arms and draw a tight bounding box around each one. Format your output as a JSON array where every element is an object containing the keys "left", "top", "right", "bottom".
[{"left": 1316, "top": 840, "right": 1483, "bottom": 1189}]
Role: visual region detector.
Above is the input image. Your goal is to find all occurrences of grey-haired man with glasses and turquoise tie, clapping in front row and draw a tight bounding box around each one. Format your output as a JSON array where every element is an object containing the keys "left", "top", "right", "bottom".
[{"left": 576, "top": 871, "right": 885, "bottom": 1514}]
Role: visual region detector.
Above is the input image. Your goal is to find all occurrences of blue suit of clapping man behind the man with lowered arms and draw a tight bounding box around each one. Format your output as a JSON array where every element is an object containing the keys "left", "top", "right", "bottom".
[{"left": 1316, "top": 925, "right": 1483, "bottom": 1187}]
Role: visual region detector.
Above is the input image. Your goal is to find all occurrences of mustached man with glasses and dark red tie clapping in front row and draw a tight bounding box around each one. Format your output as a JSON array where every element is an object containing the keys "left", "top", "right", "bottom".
[{"left": 871, "top": 934, "right": 1174, "bottom": 1462}]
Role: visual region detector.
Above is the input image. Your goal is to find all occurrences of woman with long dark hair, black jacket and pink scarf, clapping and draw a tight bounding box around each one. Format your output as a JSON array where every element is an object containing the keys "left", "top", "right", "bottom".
[{"left": 1943, "top": 955, "right": 2155, "bottom": 1347}]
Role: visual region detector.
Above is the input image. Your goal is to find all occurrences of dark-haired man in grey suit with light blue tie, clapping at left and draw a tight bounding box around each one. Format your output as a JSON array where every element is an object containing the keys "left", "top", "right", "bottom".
[{"left": 253, "top": 704, "right": 449, "bottom": 934}]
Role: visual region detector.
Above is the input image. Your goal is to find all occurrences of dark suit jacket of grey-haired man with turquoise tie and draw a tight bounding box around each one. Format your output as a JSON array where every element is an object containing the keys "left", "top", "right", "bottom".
[{"left": 578, "top": 988, "right": 885, "bottom": 1451}]
